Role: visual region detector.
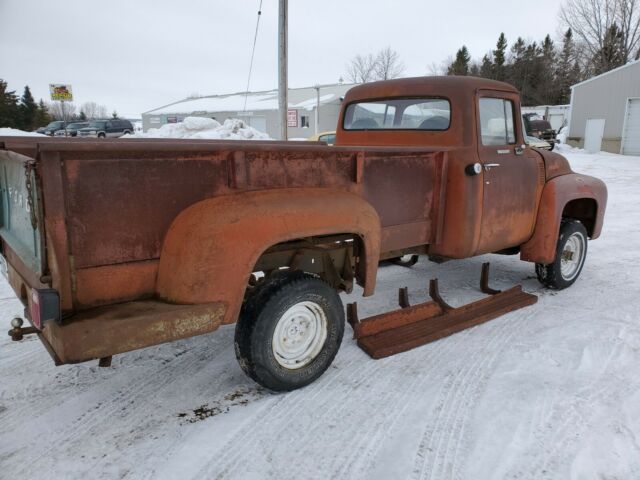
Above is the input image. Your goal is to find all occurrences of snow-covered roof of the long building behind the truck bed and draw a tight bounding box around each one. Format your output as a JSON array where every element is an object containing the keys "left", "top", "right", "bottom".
[{"left": 144, "top": 83, "right": 353, "bottom": 115}]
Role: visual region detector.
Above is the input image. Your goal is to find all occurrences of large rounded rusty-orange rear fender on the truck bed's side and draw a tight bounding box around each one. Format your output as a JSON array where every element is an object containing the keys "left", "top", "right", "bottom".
[{"left": 156, "top": 188, "right": 381, "bottom": 323}]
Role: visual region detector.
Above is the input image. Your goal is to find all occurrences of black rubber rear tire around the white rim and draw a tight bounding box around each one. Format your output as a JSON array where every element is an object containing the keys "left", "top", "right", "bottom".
[{"left": 235, "top": 272, "right": 345, "bottom": 391}]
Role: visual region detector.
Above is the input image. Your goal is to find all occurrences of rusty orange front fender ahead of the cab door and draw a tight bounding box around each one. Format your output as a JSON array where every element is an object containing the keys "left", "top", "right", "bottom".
[{"left": 520, "top": 173, "right": 607, "bottom": 264}]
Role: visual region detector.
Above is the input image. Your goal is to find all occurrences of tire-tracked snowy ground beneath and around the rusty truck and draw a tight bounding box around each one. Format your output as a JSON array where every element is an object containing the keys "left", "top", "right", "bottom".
[{"left": 0, "top": 147, "right": 640, "bottom": 480}]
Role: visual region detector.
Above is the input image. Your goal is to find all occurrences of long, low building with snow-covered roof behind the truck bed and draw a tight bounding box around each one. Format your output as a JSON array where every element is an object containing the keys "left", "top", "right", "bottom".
[{"left": 142, "top": 83, "right": 353, "bottom": 139}]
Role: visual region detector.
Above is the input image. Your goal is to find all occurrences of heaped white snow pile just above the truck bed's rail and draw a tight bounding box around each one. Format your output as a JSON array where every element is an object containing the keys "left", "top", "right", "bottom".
[{"left": 123, "top": 117, "right": 271, "bottom": 140}]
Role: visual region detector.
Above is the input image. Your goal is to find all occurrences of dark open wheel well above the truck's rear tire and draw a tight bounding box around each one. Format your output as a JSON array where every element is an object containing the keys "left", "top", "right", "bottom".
[{"left": 252, "top": 234, "right": 364, "bottom": 293}]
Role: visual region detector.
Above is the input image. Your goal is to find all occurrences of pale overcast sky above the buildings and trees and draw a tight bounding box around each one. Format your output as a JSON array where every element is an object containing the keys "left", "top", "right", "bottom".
[{"left": 0, "top": 0, "right": 561, "bottom": 117}]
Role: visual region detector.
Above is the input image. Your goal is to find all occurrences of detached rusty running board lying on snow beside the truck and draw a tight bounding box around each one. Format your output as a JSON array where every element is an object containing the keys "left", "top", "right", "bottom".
[{"left": 347, "top": 263, "right": 538, "bottom": 358}]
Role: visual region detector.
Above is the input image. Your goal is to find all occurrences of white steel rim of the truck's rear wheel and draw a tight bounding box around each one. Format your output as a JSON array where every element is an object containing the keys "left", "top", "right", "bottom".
[{"left": 271, "top": 302, "right": 327, "bottom": 370}]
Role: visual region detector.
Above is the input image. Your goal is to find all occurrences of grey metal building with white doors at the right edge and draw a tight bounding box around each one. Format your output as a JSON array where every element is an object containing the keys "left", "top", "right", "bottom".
[{"left": 567, "top": 60, "right": 640, "bottom": 155}]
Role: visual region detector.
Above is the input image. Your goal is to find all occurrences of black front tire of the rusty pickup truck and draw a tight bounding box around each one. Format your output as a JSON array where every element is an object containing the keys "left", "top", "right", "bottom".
[{"left": 536, "top": 219, "right": 588, "bottom": 290}]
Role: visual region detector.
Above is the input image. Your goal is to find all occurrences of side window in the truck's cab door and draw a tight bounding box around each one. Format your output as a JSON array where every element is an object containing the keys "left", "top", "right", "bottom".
[{"left": 480, "top": 98, "right": 516, "bottom": 145}]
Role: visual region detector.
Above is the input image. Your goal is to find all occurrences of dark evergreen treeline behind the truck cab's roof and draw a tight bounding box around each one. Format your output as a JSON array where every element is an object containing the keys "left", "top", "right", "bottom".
[{"left": 447, "top": 29, "right": 587, "bottom": 106}]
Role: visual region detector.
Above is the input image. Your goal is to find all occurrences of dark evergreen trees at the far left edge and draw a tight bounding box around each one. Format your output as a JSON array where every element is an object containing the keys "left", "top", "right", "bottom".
[{"left": 0, "top": 79, "right": 51, "bottom": 131}]
